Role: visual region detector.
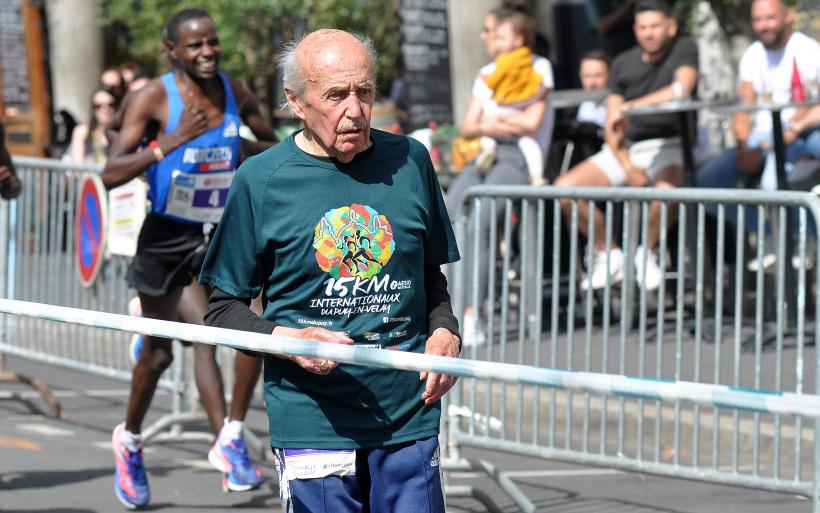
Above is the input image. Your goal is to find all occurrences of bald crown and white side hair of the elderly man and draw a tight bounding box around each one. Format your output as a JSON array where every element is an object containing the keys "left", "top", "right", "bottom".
[{"left": 279, "top": 29, "right": 378, "bottom": 104}]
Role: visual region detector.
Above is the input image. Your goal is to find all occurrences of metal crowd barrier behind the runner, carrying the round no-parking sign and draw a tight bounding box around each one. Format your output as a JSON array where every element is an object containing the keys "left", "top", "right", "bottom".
[{"left": 0, "top": 157, "right": 262, "bottom": 457}]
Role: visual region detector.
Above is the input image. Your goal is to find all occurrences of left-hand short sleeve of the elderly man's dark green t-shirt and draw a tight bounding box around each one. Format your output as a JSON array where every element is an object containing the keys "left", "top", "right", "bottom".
[{"left": 199, "top": 159, "right": 263, "bottom": 298}]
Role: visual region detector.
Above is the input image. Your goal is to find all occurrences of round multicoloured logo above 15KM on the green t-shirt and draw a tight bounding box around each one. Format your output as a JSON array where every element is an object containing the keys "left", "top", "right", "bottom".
[{"left": 313, "top": 203, "right": 396, "bottom": 279}]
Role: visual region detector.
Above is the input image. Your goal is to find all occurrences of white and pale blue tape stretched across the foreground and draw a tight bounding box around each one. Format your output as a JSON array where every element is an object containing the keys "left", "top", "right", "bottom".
[{"left": 0, "top": 299, "right": 820, "bottom": 419}]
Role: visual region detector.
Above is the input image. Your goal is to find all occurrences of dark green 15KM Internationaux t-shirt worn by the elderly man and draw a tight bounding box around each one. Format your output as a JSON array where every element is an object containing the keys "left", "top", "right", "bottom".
[{"left": 200, "top": 130, "right": 459, "bottom": 449}]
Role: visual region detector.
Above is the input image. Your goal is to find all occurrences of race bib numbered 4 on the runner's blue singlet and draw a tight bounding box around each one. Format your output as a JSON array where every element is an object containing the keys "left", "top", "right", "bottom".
[{"left": 165, "top": 171, "right": 235, "bottom": 224}]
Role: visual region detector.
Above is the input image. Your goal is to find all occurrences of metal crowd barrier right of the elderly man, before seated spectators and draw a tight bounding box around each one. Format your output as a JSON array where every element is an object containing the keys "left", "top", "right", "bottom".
[{"left": 448, "top": 186, "right": 820, "bottom": 512}]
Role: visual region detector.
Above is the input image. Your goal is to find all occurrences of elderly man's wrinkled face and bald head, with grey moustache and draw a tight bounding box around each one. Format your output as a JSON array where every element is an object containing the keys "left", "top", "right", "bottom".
[{"left": 288, "top": 31, "right": 376, "bottom": 162}]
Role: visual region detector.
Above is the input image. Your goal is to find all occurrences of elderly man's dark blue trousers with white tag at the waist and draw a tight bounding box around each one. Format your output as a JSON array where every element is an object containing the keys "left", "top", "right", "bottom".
[{"left": 273, "top": 436, "right": 445, "bottom": 513}]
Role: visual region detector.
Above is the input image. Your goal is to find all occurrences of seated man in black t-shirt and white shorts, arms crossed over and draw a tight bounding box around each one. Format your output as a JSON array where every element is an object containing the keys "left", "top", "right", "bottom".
[{"left": 555, "top": 0, "right": 698, "bottom": 290}]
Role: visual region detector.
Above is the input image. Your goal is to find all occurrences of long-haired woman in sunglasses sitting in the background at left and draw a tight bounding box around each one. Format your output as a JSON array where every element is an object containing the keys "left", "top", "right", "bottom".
[{"left": 69, "top": 89, "right": 116, "bottom": 164}]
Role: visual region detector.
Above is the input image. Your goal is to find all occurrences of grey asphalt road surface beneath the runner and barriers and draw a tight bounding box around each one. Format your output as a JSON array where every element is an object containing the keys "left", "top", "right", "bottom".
[{"left": 0, "top": 358, "right": 811, "bottom": 513}]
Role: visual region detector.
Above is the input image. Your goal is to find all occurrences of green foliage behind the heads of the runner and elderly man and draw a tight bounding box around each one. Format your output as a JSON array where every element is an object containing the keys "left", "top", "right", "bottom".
[{"left": 98, "top": 0, "right": 401, "bottom": 113}]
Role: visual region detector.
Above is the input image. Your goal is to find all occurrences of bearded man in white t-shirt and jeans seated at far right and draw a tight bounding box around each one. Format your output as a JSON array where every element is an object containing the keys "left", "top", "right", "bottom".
[{"left": 695, "top": 0, "right": 820, "bottom": 192}]
